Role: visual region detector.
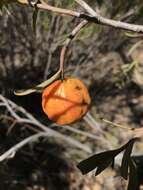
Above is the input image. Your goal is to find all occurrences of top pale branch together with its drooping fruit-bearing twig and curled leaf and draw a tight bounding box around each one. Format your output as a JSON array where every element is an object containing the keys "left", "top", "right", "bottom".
[{"left": 12, "top": 0, "right": 143, "bottom": 96}]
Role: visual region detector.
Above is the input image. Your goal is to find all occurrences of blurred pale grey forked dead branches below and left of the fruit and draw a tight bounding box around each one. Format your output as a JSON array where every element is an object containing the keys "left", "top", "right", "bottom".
[{"left": 0, "top": 94, "right": 116, "bottom": 162}]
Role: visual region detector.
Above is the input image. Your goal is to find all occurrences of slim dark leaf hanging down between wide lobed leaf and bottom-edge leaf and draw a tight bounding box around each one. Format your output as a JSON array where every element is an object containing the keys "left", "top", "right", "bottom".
[{"left": 121, "top": 140, "right": 135, "bottom": 180}]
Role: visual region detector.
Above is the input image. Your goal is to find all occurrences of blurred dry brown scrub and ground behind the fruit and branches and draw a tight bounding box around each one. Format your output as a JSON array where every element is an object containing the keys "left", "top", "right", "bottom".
[{"left": 0, "top": 0, "right": 143, "bottom": 190}]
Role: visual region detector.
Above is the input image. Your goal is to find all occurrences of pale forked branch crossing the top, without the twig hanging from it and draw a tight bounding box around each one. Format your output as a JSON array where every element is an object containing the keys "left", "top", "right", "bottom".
[{"left": 18, "top": 0, "right": 143, "bottom": 33}]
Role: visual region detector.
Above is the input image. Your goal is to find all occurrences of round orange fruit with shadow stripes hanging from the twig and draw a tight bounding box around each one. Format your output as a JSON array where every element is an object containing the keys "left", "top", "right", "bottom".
[{"left": 42, "top": 78, "right": 91, "bottom": 125}]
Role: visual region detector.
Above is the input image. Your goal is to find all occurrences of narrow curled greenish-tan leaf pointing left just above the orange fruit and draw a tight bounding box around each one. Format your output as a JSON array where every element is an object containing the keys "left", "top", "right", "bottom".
[{"left": 14, "top": 70, "right": 61, "bottom": 96}]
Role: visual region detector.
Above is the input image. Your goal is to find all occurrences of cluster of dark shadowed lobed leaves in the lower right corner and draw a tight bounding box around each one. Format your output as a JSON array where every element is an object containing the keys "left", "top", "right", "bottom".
[{"left": 77, "top": 138, "right": 138, "bottom": 190}]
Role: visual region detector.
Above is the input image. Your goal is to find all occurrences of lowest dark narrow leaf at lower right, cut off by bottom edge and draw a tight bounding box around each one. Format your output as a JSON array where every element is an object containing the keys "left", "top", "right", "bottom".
[{"left": 127, "top": 159, "right": 138, "bottom": 190}]
